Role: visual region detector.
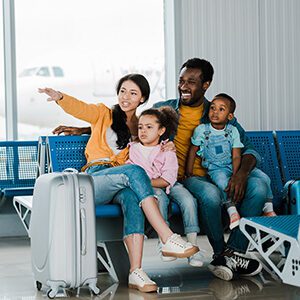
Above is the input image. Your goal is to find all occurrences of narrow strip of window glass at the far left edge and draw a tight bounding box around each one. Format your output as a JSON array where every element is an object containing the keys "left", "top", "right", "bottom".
[{"left": 0, "top": 1, "right": 6, "bottom": 140}]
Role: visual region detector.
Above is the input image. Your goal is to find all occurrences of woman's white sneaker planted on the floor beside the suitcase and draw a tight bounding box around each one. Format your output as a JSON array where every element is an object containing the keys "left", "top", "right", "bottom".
[{"left": 128, "top": 268, "right": 157, "bottom": 293}]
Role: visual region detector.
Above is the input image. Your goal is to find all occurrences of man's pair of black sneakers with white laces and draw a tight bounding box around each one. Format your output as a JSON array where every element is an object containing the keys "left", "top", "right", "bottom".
[{"left": 208, "top": 249, "right": 262, "bottom": 281}]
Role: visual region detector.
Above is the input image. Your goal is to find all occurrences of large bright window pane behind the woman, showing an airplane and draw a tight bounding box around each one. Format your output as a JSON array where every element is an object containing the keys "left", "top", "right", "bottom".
[{"left": 15, "top": 0, "right": 165, "bottom": 139}]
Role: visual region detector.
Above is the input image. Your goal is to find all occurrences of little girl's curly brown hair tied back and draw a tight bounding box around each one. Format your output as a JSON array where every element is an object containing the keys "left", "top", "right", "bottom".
[{"left": 140, "top": 106, "right": 178, "bottom": 142}]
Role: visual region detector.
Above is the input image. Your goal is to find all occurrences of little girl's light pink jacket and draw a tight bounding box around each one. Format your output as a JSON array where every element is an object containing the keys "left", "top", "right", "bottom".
[{"left": 126, "top": 142, "right": 178, "bottom": 193}]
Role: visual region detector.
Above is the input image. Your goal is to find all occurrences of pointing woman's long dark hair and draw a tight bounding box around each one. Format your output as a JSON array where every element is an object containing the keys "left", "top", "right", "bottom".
[{"left": 111, "top": 74, "right": 150, "bottom": 149}]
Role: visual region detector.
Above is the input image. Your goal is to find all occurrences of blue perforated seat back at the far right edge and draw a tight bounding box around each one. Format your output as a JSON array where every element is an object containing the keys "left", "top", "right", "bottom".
[{"left": 276, "top": 130, "right": 300, "bottom": 182}]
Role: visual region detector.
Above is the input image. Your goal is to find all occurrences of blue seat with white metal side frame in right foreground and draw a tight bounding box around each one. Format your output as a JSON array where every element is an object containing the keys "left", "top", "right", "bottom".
[{"left": 240, "top": 215, "right": 300, "bottom": 287}]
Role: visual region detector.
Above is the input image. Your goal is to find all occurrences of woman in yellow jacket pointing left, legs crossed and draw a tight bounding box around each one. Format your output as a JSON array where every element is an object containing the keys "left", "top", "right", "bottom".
[{"left": 39, "top": 74, "right": 199, "bottom": 292}]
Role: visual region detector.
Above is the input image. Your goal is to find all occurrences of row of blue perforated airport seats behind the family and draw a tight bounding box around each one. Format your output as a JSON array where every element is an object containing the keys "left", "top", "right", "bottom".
[{"left": 0, "top": 131, "right": 300, "bottom": 211}]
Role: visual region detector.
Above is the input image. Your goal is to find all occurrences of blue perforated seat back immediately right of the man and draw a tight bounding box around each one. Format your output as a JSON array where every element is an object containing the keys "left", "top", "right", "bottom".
[{"left": 246, "top": 131, "right": 283, "bottom": 209}]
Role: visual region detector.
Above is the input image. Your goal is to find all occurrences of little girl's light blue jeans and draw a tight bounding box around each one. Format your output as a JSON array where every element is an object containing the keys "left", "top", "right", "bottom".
[{"left": 154, "top": 182, "right": 200, "bottom": 234}]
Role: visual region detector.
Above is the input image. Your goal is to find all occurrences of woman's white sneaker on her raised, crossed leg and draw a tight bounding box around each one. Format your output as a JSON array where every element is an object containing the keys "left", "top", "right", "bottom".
[{"left": 161, "top": 233, "right": 199, "bottom": 258}]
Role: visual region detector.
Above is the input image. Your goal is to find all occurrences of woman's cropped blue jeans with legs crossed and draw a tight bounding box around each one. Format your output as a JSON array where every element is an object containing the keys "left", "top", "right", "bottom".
[{"left": 86, "top": 165, "right": 154, "bottom": 237}]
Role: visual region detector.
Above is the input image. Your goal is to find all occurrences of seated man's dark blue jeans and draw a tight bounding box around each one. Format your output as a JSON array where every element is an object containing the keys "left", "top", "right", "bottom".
[{"left": 183, "top": 176, "right": 268, "bottom": 255}]
